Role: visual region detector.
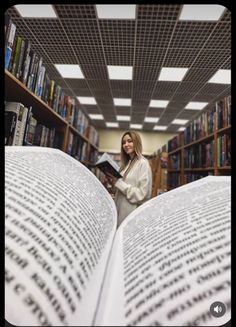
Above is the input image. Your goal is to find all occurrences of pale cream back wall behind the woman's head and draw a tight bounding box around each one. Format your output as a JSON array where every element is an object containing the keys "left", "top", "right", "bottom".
[{"left": 98, "top": 129, "right": 176, "bottom": 155}]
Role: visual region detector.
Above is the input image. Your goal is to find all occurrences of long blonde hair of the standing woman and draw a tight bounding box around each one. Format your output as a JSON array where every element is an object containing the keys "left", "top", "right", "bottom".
[{"left": 120, "top": 131, "right": 142, "bottom": 170}]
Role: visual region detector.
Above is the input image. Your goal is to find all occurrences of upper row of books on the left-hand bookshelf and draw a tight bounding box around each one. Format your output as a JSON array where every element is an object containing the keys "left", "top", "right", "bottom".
[{"left": 5, "top": 16, "right": 98, "bottom": 145}]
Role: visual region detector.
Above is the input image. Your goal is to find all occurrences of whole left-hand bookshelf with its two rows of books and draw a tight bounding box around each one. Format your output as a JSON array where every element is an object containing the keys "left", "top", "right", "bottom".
[{"left": 5, "top": 19, "right": 99, "bottom": 172}]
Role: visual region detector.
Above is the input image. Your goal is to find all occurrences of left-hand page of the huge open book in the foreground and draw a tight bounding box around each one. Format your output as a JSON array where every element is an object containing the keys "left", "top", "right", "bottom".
[{"left": 5, "top": 147, "right": 117, "bottom": 326}]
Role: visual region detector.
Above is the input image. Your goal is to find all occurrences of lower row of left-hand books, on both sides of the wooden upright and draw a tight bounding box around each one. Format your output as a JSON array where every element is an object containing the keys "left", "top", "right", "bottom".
[{"left": 5, "top": 101, "right": 97, "bottom": 162}]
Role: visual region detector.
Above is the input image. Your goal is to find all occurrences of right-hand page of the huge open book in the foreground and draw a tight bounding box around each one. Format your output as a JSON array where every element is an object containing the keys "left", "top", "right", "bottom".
[{"left": 96, "top": 176, "right": 231, "bottom": 326}]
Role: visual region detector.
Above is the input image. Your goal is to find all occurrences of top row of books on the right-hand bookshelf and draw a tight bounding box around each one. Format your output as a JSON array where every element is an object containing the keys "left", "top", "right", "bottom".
[{"left": 184, "top": 96, "right": 231, "bottom": 144}]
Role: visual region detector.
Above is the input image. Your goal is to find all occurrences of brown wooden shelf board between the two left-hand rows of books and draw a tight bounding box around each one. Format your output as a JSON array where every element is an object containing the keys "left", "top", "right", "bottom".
[{"left": 5, "top": 70, "right": 98, "bottom": 166}]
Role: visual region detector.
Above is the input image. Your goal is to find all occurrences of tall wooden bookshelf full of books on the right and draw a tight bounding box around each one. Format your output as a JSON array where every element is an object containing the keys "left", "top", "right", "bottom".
[{"left": 168, "top": 96, "right": 231, "bottom": 190}]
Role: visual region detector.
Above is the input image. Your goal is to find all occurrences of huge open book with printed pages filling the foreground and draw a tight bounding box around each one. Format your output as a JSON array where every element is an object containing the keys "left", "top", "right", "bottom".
[{"left": 5, "top": 146, "right": 231, "bottom": 326}]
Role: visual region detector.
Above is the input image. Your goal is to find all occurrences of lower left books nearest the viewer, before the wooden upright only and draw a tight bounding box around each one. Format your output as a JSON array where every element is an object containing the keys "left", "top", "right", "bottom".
[{"left": 5, "top": 102, "right": 63, "bottom": 148}]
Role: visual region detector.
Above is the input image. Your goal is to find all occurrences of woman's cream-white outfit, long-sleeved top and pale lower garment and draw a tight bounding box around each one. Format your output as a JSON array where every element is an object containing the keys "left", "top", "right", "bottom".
[{"left": 115, "top": 156, "right": 152, "bottom": 226}]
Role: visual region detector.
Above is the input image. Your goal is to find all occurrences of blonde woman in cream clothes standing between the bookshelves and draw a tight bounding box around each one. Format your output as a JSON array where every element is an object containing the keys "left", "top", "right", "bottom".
[{"left": 106, "top": 131, "right": 152, "bottom": 226}]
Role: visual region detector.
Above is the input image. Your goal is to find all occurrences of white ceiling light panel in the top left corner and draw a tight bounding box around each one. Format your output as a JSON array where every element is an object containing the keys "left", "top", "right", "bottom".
[{"left": 14, "top": 5, "right": 57, "bottom": 18}]
